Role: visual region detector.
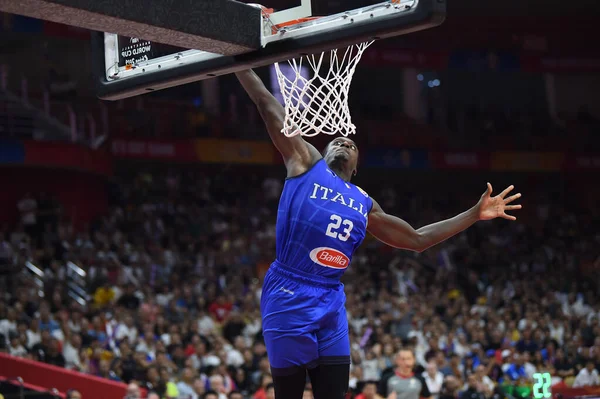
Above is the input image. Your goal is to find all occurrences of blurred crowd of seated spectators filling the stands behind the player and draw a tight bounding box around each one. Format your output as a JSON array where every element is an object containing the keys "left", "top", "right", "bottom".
[{"left": 0, "top": 170, "right": 600, "bottom": 399}]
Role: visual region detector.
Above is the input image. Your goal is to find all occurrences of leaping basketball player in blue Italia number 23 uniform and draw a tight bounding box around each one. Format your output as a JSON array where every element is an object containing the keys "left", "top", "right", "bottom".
[{"left": 236, "top": 70, "right": 521, "bottom": 399}]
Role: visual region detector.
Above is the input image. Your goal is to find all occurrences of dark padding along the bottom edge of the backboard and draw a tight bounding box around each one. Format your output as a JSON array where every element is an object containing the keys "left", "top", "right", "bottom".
[{"left": 93, "top": 0, "right": 446, "bottom": 100}]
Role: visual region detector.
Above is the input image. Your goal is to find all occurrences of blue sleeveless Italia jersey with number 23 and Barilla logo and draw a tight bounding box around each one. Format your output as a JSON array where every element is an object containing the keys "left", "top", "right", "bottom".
[{"left": 276, "top": 159, "right": 373, "bottom": 280}]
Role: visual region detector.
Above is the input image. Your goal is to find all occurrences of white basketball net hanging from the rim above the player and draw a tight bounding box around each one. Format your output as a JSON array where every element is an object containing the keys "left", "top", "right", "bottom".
[{"left": 275, "top": 41, "right": 373, "bottom": 137}]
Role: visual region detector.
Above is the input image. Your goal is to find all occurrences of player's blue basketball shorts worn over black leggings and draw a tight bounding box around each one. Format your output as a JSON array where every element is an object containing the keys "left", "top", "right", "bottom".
[{"left": 261, "top": 262, "right": 350, "bottom": 375}]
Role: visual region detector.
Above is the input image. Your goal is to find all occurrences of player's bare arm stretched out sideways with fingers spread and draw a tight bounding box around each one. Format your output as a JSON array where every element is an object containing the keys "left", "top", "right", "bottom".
[{"left": 368, "top": 183, "right": 521, "bottom": 252}]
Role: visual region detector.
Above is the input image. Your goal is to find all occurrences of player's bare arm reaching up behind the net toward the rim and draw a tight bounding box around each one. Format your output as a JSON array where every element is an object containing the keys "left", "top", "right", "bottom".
[{"left": 236, "top": 69, "right": 321, "bottom": 177}]
